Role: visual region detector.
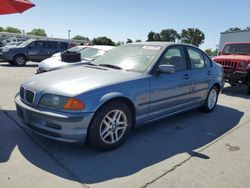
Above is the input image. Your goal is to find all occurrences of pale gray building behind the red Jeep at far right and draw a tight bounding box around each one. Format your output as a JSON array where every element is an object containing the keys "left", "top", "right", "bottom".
[{"left": 219, "top": 30, "right": 250, "bottom": 52}]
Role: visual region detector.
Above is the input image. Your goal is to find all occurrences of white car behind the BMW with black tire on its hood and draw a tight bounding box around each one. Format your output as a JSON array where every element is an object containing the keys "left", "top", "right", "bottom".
[{"left": 37, "top": 45, "right": 114, "bottom": 74}]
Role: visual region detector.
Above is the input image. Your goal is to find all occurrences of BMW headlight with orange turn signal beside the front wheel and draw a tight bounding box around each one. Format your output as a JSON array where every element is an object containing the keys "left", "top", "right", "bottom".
[{"left": 39, "top": 94, "right": 84, "bottom": 110}]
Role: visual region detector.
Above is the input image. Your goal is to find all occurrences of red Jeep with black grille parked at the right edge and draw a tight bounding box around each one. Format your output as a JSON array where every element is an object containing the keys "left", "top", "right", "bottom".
[{"left": 213, "top": 42, "right": 250, "bottom": 95}]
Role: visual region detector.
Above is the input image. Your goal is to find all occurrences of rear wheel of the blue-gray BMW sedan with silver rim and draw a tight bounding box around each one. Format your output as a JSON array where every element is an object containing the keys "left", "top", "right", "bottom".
[{"left": 201, "top": 86, "right": 219, "bottom": 112}]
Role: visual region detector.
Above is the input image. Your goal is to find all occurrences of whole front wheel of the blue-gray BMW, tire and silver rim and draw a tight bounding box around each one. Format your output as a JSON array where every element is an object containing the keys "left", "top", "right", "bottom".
[{"left": 88, "top": 101, "right": 133, "bottom": 150}]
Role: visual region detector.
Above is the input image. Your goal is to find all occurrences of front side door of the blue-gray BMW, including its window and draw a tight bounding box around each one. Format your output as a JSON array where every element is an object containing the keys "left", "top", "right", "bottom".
[{"left": 149, "top": 45, "right": 191, "bottom": 118}]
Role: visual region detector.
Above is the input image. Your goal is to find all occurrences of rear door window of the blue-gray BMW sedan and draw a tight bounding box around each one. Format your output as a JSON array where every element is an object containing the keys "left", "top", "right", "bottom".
[{"left": 187, "top": 47, "right": 205, "bottom": 69}]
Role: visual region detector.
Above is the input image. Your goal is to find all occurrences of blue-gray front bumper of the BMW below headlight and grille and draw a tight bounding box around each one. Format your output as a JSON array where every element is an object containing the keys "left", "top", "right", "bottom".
[{"left": 15, "top": 95, "right": 94, "bottom": 143}]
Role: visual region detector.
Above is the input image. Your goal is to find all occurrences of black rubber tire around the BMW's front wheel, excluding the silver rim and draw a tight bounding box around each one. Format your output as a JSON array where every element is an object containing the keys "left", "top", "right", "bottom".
[{"left": 87, "top": 101, "right": 133, "bottom": 150}]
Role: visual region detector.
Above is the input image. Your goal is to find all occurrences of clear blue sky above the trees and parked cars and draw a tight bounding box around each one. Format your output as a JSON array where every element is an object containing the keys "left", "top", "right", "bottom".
[{"left": 0, "top": 0, "right": 250, "bottom": 49}]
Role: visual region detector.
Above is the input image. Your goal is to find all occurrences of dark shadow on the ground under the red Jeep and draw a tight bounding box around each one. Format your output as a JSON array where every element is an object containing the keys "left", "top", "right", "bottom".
[{"left": 222, "top": 85, "right": 250, "bottom": 99}]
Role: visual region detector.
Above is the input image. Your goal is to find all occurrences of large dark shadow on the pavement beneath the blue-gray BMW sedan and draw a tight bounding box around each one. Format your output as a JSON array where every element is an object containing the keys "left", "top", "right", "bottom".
[{"left": 0, "top": 105, "right": 244, "bottom": 184}]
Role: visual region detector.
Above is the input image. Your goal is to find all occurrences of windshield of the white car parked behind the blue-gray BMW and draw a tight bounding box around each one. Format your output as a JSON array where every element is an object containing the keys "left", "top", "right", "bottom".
[{"left": 80, "top": 47, "right": 105, "bottom": 61}]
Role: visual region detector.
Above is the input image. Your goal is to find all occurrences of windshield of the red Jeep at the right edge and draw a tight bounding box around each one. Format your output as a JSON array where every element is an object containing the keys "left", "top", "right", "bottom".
[{"left": 224, "top": 44, "right": 250, "bottom": 55}]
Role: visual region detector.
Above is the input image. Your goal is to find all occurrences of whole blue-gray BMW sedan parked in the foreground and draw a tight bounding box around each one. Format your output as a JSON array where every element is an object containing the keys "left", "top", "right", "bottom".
[{"left": 15, "top": 42, "right": 224, "bottom": 150}]
